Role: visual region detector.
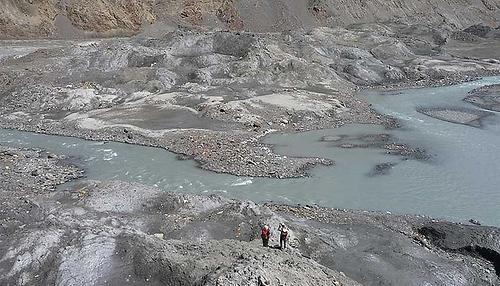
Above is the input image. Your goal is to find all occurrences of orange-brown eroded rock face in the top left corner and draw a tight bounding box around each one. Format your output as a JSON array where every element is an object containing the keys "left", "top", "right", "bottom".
[{"left": 0, "top": 0, "right": 155, "bottom": 39}]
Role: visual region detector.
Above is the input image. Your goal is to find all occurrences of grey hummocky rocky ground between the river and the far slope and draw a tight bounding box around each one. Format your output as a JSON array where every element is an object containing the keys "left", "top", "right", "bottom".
[{"left": 0, "top": 24, "right": 500, "bottom": 178}]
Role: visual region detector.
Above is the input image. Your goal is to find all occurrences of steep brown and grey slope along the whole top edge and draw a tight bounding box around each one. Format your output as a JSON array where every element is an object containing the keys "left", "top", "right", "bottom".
[{"left": 0, "top": 0, "right": 500, "bottom": 39}]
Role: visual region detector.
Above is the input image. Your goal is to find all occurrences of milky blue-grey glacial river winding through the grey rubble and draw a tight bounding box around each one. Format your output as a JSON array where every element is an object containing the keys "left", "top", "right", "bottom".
[{"left": 0, "top": 77, "right": 500, "bottom": 226}]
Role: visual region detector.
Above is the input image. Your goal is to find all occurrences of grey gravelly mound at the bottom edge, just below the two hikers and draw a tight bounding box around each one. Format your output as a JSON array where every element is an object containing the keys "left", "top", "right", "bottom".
[{"left": 119, "top": 236, "right": 359, "bottom": 286}]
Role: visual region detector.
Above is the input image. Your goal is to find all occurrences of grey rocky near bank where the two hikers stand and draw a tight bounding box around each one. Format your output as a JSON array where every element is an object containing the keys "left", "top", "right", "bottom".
[{"left": 0, "top": 147, "right": 500, "bottom": 285}]
